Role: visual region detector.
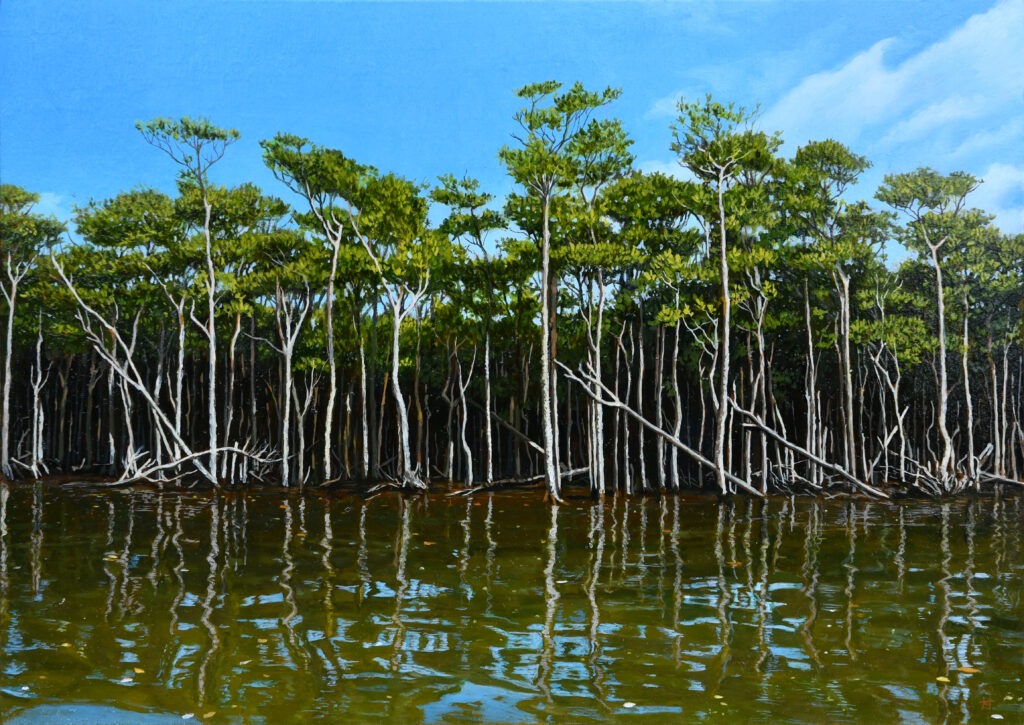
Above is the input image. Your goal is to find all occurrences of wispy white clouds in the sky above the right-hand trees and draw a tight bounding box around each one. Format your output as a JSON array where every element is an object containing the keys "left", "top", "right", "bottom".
[{"left": 640, "top": 0, "right": 1024, "bottom": 233}]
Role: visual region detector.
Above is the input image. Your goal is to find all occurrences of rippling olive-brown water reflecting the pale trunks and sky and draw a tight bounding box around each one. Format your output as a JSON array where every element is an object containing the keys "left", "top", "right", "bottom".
[{"left": 0, "top": 485, "right": 1024, "bottom": 723}]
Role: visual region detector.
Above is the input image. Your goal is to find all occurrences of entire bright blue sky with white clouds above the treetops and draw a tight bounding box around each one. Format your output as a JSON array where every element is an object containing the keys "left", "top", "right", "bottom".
[{"left": 0, "top": 0, "right": 1024, "bottom": 247}]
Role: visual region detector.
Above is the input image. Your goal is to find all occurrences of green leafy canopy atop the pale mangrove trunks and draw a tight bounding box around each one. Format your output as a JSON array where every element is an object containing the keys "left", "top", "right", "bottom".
[{"left": 0, "top": 86, "right": 1024, "bottom": 493}]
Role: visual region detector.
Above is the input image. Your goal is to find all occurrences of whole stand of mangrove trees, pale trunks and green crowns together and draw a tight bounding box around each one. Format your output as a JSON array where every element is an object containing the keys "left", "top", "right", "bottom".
[{"left": 0, "top": 82, "right": 1024, "bottom": 499}]
